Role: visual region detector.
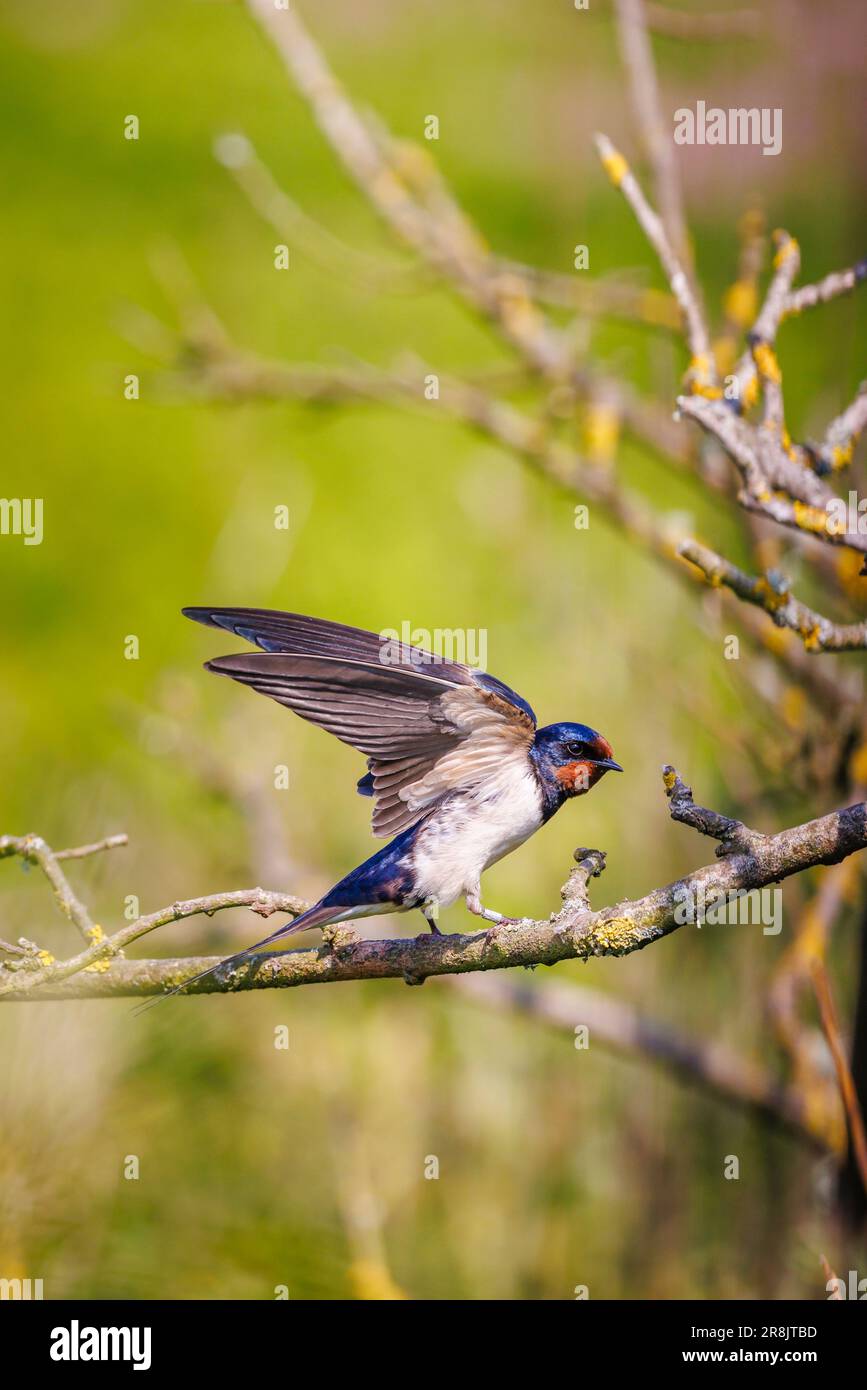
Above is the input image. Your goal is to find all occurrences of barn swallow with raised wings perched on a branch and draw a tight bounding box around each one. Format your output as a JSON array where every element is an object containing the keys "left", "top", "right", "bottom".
[{"left": 162, "top": 607, "right": 622, "bottom": 988}]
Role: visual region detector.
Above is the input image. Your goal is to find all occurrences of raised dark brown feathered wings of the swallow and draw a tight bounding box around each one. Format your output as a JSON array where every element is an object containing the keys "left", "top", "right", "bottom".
[{"left": 183, "top": 607, "right": 536, "bottom": 835}]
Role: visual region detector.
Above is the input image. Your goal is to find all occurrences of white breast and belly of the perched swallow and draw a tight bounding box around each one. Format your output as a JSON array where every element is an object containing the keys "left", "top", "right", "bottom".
[{"left": 413, "top": 756, "right": 542, "bottom": 906}]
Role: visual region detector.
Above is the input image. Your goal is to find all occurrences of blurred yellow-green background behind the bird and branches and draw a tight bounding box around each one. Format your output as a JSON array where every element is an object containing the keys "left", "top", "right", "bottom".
[{"left": 0, "top": 0, "right": 866, "bottom": 1298}]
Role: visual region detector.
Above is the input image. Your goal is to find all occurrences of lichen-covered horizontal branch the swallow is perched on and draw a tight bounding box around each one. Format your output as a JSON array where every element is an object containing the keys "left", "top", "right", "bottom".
[{"left": 0, "top": 767, "right": 867, "bottom": 1001}]
